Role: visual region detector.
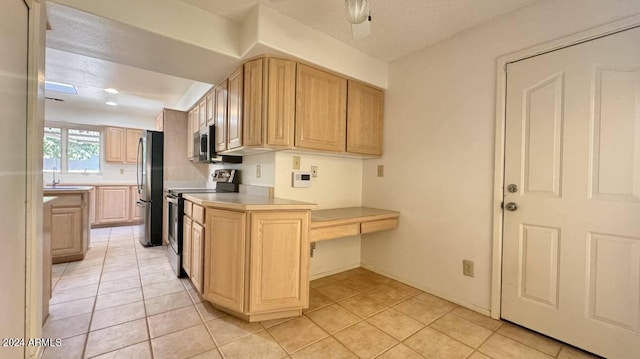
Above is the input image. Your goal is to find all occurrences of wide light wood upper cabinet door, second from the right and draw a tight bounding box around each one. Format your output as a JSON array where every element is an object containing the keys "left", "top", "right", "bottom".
[{"left": 295, "top": 63, "right": 347, "bottom": 152}]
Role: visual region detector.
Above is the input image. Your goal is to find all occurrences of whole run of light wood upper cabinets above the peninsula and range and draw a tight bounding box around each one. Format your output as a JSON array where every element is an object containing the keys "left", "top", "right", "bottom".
[{"left": 189, "top": 56, "right": 384, "bottom": 157}]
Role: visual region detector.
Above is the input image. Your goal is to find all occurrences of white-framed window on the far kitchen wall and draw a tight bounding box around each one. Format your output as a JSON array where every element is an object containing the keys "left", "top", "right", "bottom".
[{"left": 43, "top": 125, "right": 101, "bottom": 173}]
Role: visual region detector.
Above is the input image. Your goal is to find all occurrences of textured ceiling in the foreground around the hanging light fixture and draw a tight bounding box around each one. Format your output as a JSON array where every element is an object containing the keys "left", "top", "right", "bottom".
[{"left": 182, "top": 0, "right": 538, "bottom": 61}]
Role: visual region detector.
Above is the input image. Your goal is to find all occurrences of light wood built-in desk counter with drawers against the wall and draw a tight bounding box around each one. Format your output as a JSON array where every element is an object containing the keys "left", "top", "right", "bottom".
[{"left": 310, "top": 207, "right": 400, "bottom": 242}]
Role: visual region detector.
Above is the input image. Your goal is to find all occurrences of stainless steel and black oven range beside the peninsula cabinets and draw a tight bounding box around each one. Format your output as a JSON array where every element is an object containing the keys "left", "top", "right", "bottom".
[{"left": 166, "top": 169, "right": 238, "bottom": 277}]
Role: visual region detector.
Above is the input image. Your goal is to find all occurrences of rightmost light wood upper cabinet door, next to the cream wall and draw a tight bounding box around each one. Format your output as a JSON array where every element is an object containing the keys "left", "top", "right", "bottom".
[{"left": 347, "top": 80, "right": 384, "bottom": 156}]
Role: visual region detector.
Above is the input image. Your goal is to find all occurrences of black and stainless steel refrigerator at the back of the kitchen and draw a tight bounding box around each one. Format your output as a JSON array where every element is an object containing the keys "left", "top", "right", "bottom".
[{"left": 136, "top": 131, "right": 164, "bottom": 247}]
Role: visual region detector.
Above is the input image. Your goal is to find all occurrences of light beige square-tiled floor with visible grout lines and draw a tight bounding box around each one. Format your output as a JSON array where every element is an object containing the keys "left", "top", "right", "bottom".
[{"left": 43, "top": 227, "right": 595, "bottom": 359}]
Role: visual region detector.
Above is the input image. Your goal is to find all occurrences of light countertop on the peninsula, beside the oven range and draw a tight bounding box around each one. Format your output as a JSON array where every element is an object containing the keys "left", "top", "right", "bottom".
[{"left": 183, "top": 193, "right": 317, "bottom": 211}]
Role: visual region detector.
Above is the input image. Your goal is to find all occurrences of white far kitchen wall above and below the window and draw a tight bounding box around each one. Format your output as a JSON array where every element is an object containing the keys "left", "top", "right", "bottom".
[{"left": 43, "top": 101, "right": 156, "bottom": 184}]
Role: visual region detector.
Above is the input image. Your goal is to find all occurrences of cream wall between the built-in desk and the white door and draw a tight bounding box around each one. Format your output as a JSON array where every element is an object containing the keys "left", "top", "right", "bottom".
[{"left": 362, "top": 0, "right": 640, "bottom": 313}]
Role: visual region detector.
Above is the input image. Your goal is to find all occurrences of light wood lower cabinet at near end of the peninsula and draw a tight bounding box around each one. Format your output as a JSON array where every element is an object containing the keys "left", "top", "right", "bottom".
[{"left": 201, "top": 208, "right": 310, "bottom": 322}]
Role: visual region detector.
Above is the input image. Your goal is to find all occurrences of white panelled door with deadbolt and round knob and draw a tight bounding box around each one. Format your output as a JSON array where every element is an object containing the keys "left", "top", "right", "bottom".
[{"left": 501, "top": 28, "right": 640, "bottom": 358}]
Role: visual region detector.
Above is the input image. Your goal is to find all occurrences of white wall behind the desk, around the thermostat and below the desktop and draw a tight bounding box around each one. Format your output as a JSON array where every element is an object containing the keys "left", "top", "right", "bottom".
[{"left": 274, "top": 152, "right": 362, "bottom": 279}]
